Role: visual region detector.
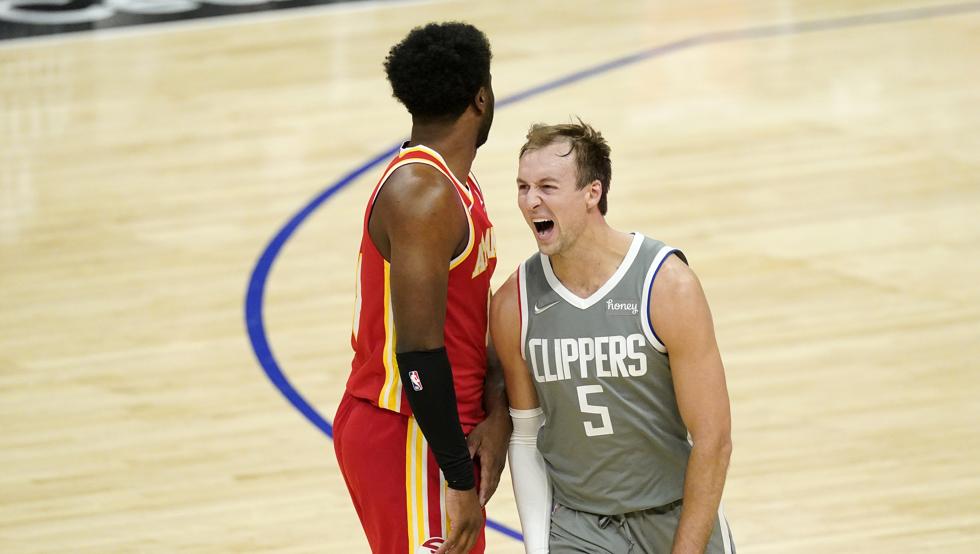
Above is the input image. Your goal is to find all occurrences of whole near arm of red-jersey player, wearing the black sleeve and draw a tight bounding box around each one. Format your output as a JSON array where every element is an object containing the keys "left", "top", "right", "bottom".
[{"left": 368, "top": 164, "right": 483, "bottom": 552}]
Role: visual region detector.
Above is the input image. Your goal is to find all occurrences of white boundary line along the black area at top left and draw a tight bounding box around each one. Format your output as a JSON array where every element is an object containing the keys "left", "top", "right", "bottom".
[{"left": 0, "top": 0, "right": 444, "bottom": 51}]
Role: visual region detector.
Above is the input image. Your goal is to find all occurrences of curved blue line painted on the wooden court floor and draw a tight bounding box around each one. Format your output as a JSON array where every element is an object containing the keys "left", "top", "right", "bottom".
[{"left": 245, "top": 2, "right": 980, "bottom": 540}]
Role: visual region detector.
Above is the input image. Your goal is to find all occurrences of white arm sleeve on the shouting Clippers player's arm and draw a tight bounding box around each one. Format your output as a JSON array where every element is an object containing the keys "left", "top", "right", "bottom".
[{"left": 509, "top": 408, "right": 551, "bottom": 554}]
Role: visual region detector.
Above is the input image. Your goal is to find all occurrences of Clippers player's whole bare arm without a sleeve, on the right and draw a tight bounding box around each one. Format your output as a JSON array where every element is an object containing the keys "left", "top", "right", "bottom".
[{"left": 650, "top": 256, "right": 732, "bottom": 554}]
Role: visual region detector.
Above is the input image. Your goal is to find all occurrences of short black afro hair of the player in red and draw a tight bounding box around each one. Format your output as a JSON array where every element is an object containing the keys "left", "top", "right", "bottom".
[{"left": 384, "top": 22, "right": 492, "bottom": 120}]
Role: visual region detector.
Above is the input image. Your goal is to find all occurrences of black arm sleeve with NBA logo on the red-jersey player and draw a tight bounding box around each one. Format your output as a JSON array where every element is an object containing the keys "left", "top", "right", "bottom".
[{"left": 395, "top": 347, "right": 476, "bottom": 490}]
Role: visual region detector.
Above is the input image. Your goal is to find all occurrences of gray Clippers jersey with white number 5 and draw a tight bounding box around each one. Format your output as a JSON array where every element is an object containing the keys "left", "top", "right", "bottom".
[{"left": 519, "top": 233, "right": 691, "bottom": 515}]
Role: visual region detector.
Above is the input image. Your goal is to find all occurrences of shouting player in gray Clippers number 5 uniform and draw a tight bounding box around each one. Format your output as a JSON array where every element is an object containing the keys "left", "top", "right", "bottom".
[{"left": 490, "top": 121, "right": 735, "bottom": 554}]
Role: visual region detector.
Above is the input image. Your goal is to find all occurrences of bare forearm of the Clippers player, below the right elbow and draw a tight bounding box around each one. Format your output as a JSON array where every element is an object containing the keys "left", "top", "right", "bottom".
[{"left": 672, "top": 439, "right": 731, "bottom": 554}]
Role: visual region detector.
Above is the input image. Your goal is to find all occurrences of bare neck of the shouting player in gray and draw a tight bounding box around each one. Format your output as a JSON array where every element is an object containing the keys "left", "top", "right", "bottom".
[{"left": 551, "top": 220, "right": 633, "bottom": 297}]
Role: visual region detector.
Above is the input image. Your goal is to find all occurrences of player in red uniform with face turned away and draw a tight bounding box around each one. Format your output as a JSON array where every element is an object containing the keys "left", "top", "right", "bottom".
[{"left": 334, "top": 23, "right": 510, "bottom": 554}]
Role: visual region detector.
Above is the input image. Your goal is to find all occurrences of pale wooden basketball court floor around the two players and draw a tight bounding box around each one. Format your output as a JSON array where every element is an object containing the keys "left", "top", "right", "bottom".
[{"left": 0, "top": 0, "right": 980, "bottom": 553}]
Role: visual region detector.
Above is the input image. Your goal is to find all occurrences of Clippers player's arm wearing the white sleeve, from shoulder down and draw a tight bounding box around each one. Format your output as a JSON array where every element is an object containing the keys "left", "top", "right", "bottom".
[{"left": 490, "top": 274, "right": 551, "bottom": 554}]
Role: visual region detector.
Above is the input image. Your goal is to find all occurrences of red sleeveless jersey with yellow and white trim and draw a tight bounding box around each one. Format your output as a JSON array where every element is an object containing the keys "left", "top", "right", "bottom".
[{"left": 347, "top": 142, "right": 497, "bottom": 433}]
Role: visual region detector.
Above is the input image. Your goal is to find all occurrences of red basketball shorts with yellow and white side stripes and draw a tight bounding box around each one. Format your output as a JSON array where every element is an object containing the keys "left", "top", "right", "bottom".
[{"left": 333, "top": 393, "right": 486, "bottom": 554}]
